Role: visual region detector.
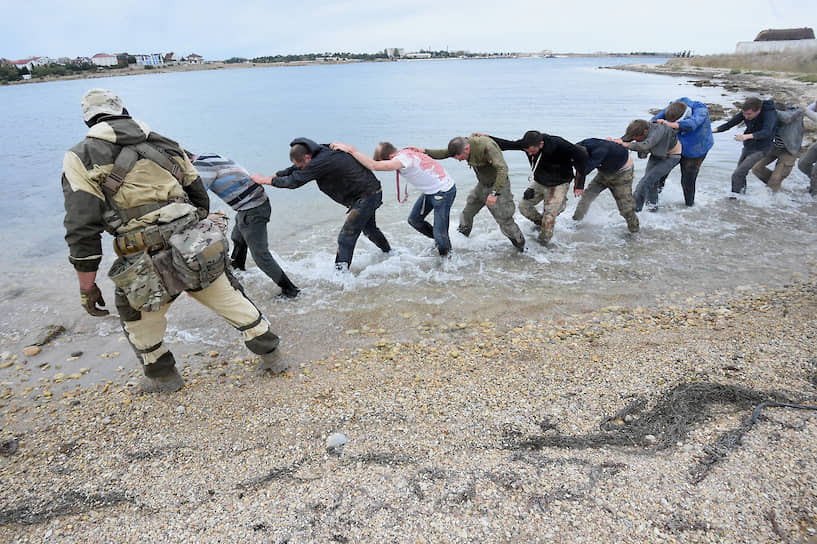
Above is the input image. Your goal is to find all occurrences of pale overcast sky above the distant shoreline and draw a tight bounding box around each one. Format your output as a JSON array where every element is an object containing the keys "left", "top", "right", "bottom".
[{"left": 0, "top": 0, "right": 817, "bottom": 60}]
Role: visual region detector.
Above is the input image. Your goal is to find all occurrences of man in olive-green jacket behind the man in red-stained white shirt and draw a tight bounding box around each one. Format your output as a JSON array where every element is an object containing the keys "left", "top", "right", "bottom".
[{"left": 415, "top": 136, "right": 525, "bottom": 251}]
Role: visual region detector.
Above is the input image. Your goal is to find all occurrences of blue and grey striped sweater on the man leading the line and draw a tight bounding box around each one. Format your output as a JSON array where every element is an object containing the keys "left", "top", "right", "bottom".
[{"left": 193, "top": 153, "right": 267, "bottom": 212}]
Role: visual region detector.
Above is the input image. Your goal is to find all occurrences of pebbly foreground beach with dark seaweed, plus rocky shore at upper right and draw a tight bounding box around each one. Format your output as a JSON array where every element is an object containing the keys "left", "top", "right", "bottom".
[{"left": 0, "top": 61, "right": 817, "bottom": 544}]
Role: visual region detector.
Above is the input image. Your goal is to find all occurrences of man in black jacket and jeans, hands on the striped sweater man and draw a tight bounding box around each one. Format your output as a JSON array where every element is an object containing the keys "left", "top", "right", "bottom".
[{"left": 250, "top": 138, "right": 391, "bottom": 270}]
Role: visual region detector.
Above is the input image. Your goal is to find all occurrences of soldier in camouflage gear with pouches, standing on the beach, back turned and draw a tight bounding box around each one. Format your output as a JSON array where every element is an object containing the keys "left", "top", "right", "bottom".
[{"left": 62, "top": 89, "right": 286, "bottom": 393}]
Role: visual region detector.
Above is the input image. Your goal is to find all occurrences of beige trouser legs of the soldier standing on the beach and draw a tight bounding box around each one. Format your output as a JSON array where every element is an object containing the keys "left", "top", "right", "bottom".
[{"left": 115, "top": 272, "right": 278, "bottom": 377}]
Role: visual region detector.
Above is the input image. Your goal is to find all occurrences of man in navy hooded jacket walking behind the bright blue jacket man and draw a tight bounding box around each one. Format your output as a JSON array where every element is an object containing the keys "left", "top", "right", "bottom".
[{"left": 712, "top": 97, "right": 777, "bottom": 193}]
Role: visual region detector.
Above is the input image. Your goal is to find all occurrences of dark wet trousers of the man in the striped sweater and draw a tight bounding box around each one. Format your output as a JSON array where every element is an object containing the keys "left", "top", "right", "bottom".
[{"left": 230, "top": 201, "right": 284, "bottom": 284}]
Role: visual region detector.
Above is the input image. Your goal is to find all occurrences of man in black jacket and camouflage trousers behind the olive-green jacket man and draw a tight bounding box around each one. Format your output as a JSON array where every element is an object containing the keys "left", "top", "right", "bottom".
[{"left": 482, "top": 130, "right": 587, "bottom": 244}]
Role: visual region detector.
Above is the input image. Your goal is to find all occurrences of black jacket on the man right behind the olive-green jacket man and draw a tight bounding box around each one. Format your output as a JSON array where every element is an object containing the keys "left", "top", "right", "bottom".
[{"left": 491, "top": 133, "right": 587, "bottom": 189}]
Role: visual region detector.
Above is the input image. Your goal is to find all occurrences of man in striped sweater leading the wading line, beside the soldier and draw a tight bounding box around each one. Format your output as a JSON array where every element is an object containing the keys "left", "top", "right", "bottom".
[{"left": 190, "top": 153, "right": 301, "bottom": 298}]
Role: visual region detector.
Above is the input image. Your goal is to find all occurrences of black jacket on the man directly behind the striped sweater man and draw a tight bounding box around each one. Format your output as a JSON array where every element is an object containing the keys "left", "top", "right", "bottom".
[{"left": 272, "top": 138, "right": 380, "bottom": 208}]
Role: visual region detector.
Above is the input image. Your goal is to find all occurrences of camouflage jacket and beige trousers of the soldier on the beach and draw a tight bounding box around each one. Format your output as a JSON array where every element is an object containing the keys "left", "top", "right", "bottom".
[{"left": 62, "top": 89, "right": 278, "bottom": 387}]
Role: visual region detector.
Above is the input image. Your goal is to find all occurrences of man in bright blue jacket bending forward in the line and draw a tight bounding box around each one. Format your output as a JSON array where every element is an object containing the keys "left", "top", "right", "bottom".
[{"left": 651, "top": 96, "right": 714, "bottom": 206}]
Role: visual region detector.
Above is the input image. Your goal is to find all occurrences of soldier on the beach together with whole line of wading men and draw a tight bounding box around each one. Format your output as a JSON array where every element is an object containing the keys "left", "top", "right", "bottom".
[{"left": 62, "top": 89, "right": 817, "bottom": 392}]
